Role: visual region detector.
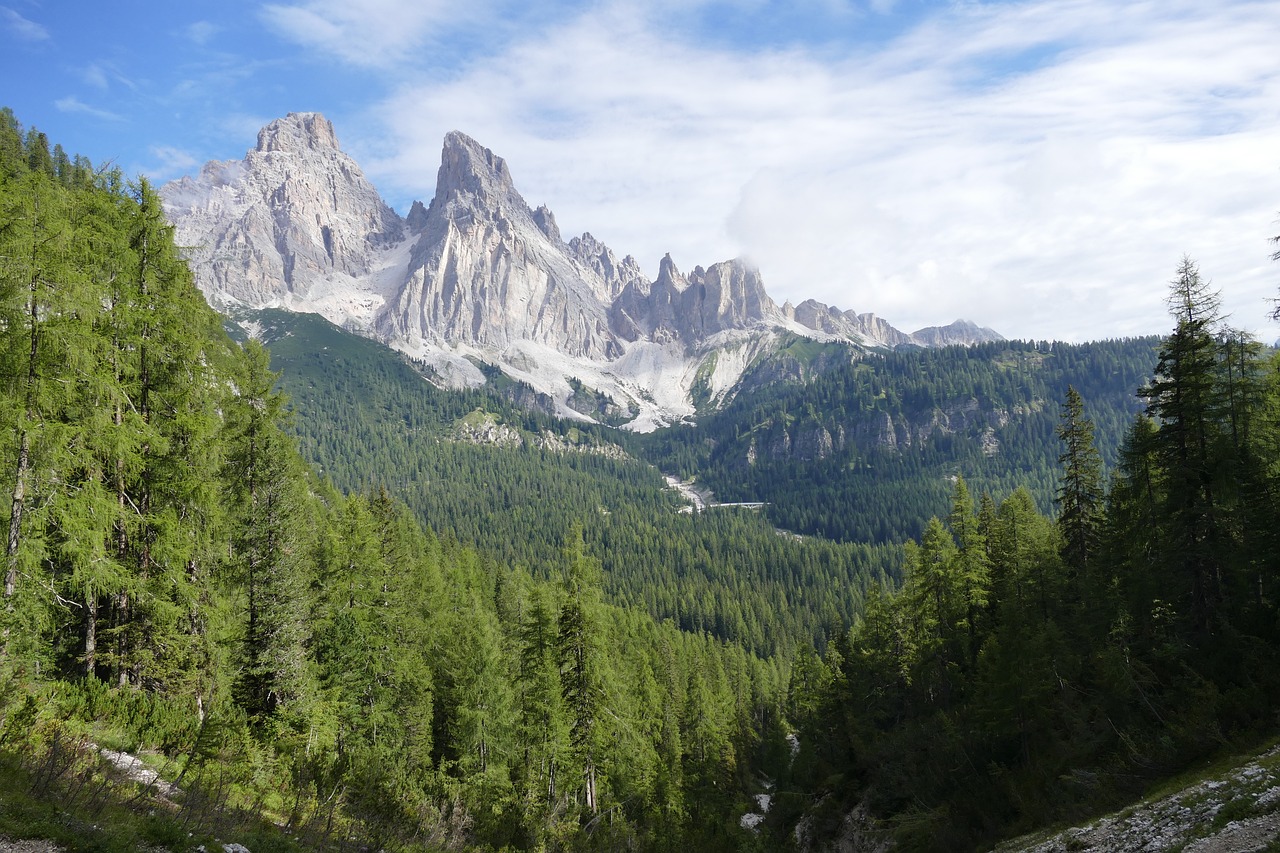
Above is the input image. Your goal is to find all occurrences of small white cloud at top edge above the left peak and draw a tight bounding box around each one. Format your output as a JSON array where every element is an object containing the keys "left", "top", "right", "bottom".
[{"left": 261, "top": 0, "right": 489, "bottom": 67}]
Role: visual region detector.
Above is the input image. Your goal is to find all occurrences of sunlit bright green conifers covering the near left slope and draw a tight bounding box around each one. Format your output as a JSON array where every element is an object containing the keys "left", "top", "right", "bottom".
[{"left": 0, "top": 113, "right": 787, "bottom": 850}]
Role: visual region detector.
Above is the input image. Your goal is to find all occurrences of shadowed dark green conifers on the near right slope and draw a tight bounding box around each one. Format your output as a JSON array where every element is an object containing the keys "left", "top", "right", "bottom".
[{"left": 792, "top": 260, "right": 1280, "bottom": 849}]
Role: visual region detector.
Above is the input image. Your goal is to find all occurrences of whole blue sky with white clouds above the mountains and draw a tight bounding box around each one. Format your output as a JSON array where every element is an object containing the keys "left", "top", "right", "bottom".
[{"left": 0, "top": 0, "right": 1280, "bottom": 343}]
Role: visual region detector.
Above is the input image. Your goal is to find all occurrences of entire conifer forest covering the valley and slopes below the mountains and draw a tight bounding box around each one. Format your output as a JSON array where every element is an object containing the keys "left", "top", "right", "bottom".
[{"left": 0, "top": 110, "right": 1280, "bottom": 853}]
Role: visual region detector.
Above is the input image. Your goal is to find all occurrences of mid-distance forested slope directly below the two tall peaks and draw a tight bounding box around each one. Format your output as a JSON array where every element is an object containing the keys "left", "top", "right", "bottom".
[{"left": 257, "top": 311, "right": 901, "bottom": 653}]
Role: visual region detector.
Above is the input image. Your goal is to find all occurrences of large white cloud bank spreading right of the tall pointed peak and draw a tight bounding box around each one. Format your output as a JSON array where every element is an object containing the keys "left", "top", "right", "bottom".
[{"left": 348, "top": 0, "right": 1280, "bottom": 339}]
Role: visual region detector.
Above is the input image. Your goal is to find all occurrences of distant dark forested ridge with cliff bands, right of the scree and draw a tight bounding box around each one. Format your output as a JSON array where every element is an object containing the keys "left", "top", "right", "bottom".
[{"left": 635, "top": 338, "right": 1158, "bottom": 543}]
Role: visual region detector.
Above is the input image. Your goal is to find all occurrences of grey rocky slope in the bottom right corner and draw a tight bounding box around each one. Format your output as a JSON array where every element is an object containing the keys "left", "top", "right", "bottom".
[{"left": 996, "top": 747, "right": 1280, "bottom": 853}]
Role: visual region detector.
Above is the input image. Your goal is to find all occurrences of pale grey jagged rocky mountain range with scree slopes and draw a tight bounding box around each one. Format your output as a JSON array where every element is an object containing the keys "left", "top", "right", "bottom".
[{"left": 161, "top": 113, "right": 1001, "bottom": 432}]
